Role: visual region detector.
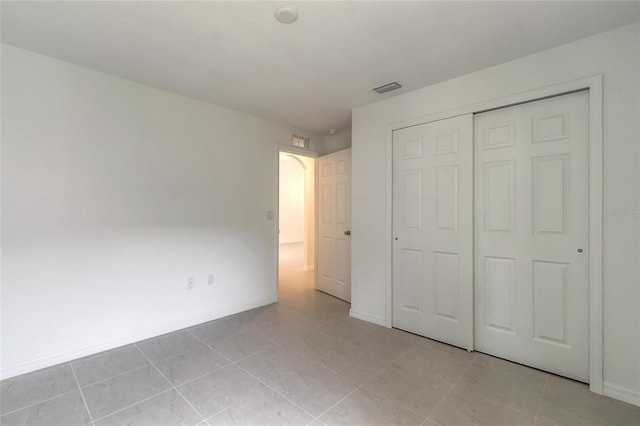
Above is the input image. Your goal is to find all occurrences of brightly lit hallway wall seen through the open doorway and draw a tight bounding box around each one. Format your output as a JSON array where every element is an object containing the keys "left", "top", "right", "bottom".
[{"left": 278, "top": 155, "right": 305, "bottom": 244}]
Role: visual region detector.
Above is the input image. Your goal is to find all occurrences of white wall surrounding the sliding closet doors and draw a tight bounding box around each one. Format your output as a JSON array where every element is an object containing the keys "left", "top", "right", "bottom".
[{"left": 352, "top": 24, "right": 640, "bottom": 404}]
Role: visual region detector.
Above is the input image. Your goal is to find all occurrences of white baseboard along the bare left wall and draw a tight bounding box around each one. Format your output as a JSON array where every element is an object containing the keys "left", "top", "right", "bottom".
[{"left": 0, "top": 299, "right": 276, "bottom": 380}]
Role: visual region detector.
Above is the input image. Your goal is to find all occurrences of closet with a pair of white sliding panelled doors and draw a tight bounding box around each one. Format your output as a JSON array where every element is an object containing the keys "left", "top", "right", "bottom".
[{"left": 392, "top": 91, "right": 589, "bottom": 381}]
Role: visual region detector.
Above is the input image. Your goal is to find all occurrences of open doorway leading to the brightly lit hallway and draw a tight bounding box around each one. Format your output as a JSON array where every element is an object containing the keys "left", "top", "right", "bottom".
[{"left": 278, "top": 151, "right": 316, "bottom": 299}]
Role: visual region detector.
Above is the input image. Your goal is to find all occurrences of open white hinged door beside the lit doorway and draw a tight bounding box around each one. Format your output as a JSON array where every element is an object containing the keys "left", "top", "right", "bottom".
[{"left": 317, "top": 149, "right": 351, "bottom": 302}]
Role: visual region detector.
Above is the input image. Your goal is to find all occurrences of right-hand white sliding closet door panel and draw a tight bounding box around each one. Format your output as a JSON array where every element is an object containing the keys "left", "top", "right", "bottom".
[{"left": 474, "top": 91, "right": 589, "bottom": 381}]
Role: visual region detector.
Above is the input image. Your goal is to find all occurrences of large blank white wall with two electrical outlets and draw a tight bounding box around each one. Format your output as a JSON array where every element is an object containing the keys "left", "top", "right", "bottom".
[{"left": 1, "top": 45, "right": 319, "bottom": 377}]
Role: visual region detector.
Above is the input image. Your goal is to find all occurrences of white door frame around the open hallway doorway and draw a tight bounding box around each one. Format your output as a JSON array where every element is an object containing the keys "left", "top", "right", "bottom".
[{"left": 273, "top": 144, "right": 319, "bottom": 302}]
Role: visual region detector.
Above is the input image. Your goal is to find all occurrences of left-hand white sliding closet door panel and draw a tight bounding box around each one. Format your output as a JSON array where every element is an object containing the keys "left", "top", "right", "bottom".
[{"left": 393, "top": 114, "right": 473, "bottom": 349}]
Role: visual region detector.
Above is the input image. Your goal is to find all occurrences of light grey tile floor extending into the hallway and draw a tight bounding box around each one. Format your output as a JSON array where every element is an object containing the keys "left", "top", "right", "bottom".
[{"left": 0, "top": 243, "right": 640, "bottom": 426}]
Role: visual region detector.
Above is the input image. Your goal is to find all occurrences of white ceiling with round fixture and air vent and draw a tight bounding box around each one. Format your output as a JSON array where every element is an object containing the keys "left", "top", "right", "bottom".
[{"left": 1, "top": 1, "right": 640, "bottom": 134}]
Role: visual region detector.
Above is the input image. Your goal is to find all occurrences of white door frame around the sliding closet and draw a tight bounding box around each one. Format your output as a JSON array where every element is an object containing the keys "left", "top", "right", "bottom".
[{"left": 385, "top": 74, "right": 603, "bottom": 394}]
